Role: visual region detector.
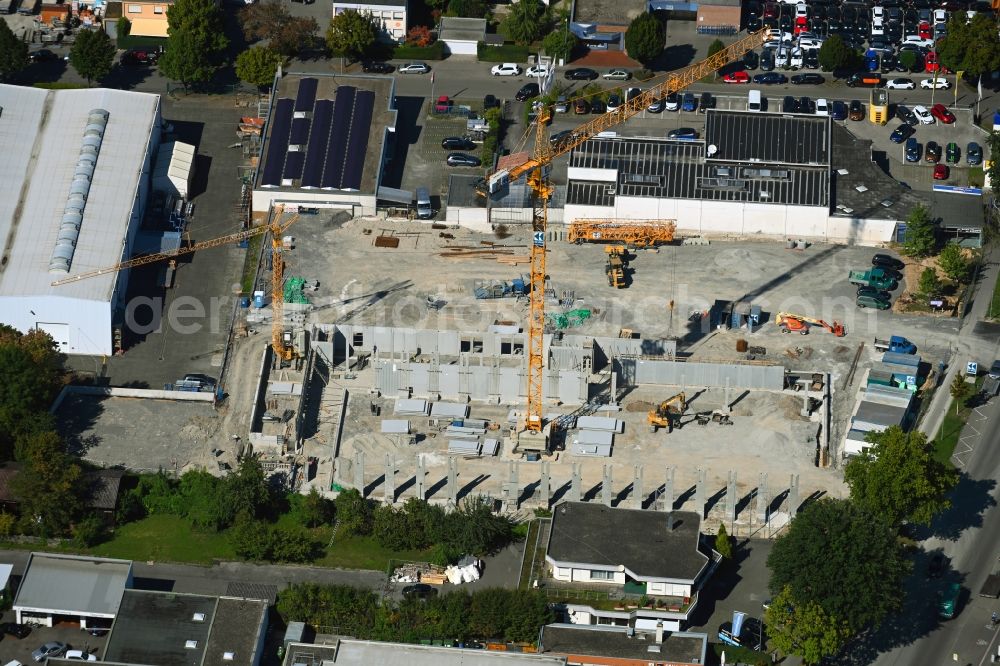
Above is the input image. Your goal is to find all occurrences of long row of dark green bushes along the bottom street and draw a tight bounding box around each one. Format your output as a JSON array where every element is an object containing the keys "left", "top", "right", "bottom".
[{"left": 276, "top": 583, "right": 554, "bottom": 643}]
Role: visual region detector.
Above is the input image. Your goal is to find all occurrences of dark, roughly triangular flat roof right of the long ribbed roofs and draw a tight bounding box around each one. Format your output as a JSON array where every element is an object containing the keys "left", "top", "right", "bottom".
[{"left": 830, "top": 124, "right": 930, "bottom": 220}]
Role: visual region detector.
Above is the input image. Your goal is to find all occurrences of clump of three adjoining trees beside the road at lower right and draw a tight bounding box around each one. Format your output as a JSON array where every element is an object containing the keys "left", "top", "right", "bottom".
[{"left": 766, "top": 426, "right": 958, "bottom": 664}]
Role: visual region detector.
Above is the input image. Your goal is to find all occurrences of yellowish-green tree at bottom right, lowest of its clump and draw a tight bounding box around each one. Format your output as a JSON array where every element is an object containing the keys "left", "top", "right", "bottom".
[{"left": 764, "top": 587, "right": 850, "bottom": 665}]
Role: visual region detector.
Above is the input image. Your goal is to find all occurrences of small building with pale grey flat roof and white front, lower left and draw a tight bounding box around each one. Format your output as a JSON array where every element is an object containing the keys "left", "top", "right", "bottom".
[{"left": 14, "top": 553, "right": 132, "bottom": 629}]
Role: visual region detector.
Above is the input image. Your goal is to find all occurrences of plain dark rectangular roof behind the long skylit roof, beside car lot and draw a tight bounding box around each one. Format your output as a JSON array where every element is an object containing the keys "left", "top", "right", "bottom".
[{"left": 705, "top": 109, "right": 831, "bottom": 166}]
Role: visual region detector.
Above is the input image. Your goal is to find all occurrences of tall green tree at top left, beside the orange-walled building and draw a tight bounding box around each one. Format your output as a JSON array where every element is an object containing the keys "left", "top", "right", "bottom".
[{"left": 159, "top": 0, "right": 229, "bottom": 88}]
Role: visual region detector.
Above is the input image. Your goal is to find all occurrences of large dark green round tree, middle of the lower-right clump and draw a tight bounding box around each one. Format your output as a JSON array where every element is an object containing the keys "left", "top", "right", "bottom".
[{"left": 767, "top": 499, "right": 909, "bottom": 635}]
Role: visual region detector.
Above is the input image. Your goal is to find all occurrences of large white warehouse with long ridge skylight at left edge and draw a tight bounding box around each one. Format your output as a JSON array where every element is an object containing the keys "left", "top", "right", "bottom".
[{"left": 0, "top": 85, "right": 161, "bottom": 355}]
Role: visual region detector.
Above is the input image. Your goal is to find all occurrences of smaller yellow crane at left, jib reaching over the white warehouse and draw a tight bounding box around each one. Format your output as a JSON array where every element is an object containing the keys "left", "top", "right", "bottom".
[{"left": 52, "top": 204, "right": 299, "bottom": 361}]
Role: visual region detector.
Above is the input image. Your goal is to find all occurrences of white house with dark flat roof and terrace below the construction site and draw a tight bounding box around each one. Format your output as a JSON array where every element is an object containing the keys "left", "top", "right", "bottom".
[{"left": 545, "top": 502, "right": 721, "bottom": 631}]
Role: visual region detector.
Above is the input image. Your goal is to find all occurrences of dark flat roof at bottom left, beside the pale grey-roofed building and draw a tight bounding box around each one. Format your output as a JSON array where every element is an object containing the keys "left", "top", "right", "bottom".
[{"left": 104, "top": 590, "right": 267, "bottom": 666}]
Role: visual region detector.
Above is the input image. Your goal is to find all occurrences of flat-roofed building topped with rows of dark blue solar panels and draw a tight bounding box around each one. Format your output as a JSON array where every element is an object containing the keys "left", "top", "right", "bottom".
[{"left": 253, "top": 70, "right": 396, "bottom": 216}]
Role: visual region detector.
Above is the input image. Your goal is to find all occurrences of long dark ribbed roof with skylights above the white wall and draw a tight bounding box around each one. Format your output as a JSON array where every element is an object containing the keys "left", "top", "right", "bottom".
[{"left": 566, "top": 138, "right": 830, "bottom": 207}]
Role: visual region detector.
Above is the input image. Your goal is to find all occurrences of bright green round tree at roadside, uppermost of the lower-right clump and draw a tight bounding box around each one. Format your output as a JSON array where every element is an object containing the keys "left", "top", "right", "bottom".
[{"left": 844, "top": 426, "right": 958, "bottom": 525}]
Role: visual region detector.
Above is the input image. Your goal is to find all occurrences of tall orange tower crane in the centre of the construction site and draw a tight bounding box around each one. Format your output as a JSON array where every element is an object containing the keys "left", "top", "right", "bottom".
[{"left": 479, "top": 29, "right": 768, "bottom": 450}]
